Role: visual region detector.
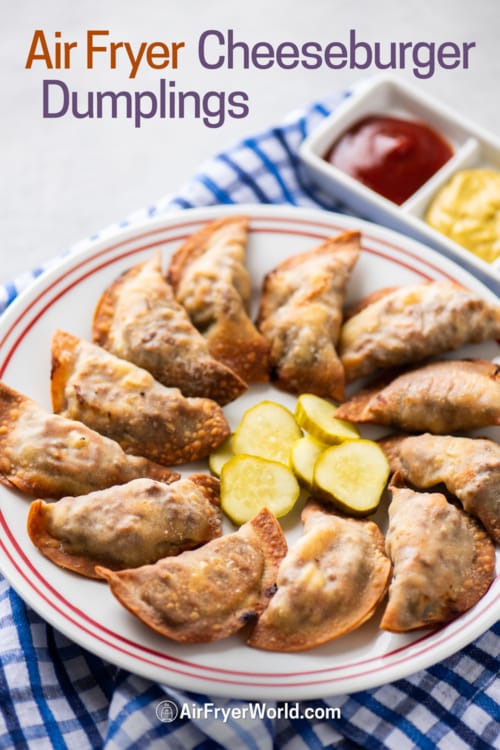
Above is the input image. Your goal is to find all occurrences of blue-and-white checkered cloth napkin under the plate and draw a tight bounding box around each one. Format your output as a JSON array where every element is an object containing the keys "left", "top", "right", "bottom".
[{"left": 0, "top": 86, "right": 500, "bottom": 750}]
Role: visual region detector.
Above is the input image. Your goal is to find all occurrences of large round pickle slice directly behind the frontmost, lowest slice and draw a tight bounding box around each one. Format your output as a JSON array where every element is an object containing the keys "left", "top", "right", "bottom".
[{"left": 233, "top": 401, "right": 302, "bottom": 466}]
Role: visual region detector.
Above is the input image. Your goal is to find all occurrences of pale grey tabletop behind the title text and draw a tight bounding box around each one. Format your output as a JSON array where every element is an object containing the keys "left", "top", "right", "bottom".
[{"left": 0, "top": 0, "right": 500, "bottom": 281}]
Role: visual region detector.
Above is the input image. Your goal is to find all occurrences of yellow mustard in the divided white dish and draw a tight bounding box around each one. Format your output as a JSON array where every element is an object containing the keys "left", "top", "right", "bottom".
[{"left": 425, "top": 169, "right": 500, "bottom": 263}]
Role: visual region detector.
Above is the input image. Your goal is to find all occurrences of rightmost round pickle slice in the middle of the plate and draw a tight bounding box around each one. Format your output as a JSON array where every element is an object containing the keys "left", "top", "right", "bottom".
[{"left": 313, "top": 440, "right": 390, "bottom": 516}]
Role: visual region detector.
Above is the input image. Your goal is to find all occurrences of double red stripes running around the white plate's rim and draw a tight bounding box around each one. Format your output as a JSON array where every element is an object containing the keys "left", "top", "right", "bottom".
[{"left": 0, "top": 215, "right": 492, "bottom": 688}]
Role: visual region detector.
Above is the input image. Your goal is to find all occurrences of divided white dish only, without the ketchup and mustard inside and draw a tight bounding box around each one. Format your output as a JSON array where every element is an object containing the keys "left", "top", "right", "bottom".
[{"left": 299, "top": 75, "right": 500, "bottom": 293}]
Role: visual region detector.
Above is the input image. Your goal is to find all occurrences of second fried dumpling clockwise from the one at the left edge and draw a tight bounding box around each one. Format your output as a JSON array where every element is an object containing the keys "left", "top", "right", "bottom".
[{"left": 93, "top": 252, "right": 247, "bottom": 404}]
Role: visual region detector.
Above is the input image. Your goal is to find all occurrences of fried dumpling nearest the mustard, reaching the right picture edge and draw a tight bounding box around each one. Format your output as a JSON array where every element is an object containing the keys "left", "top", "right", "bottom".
[{"left": 339, "top": 281, "right": 500, "bottom": 383}]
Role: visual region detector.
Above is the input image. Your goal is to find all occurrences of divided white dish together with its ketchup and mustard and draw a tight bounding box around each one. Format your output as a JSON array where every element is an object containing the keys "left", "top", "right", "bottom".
[{"left": 300, "top": 75, "right": 500, "bottom": 291}]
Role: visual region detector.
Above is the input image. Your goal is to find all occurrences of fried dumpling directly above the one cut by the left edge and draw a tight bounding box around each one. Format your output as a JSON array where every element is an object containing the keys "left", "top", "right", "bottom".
[{"left": 51, "top": 331, "right": 230, "bottom": 465}]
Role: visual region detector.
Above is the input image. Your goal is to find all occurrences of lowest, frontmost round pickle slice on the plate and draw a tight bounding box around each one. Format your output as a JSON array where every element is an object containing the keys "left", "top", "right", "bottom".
[{"left": 220, "top": 455, "right": 300, "bottom": 525}]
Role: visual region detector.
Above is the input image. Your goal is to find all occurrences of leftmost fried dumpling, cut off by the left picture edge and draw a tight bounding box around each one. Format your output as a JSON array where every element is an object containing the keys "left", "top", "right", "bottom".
[{"left": 0, "top": 383, "right": 179, "bottom": 498}]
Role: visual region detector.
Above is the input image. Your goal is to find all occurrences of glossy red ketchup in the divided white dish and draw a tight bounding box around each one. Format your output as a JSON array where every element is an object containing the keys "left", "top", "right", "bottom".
[{"left": 324, "top": 115, "right": 453, "bottom": 205}]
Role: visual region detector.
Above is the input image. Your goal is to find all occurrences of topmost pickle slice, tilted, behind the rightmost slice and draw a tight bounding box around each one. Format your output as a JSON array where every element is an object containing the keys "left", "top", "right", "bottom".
[{"left": 295, "top": 393, "right": 359, "bottom": 445}]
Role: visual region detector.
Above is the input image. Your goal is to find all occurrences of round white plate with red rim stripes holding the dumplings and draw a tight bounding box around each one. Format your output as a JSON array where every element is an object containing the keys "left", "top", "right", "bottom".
[{"left": 0, "top": 206, "right": 500, "bottom": 700}]
